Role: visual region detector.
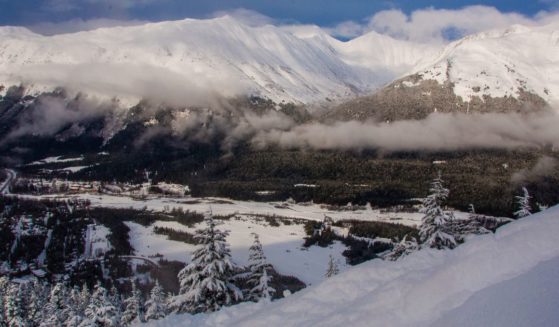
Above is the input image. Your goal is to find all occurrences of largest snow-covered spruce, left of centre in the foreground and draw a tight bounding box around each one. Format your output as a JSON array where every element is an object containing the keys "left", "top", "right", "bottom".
[{"left": 173, "top": 212, "right": 242, "bottom": 313}]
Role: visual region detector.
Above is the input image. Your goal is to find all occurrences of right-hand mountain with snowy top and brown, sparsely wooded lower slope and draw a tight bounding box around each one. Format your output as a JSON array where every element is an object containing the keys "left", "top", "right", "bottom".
[{"left": 326, "top": 23, "right": 559, "bottom": 121}]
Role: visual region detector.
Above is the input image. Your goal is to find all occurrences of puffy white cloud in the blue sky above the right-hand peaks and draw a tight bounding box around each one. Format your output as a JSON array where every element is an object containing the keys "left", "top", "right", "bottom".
[{"left": 329, "top": 6, "right": 559, "bottom": 43}]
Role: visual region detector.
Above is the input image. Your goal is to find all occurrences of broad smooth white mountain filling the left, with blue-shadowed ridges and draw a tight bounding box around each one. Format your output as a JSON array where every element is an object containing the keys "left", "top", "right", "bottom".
[{"left": 0, "top": 16, "right": 438, "bottom": 102}]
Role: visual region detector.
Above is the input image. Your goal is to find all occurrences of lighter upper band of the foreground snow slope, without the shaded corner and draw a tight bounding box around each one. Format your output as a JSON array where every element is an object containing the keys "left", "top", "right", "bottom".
[{"left": 148, "top": 206, "right": 559, "bottom": 327}]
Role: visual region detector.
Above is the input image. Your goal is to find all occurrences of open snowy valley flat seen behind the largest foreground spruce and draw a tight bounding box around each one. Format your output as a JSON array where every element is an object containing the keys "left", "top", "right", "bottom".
[{"left": 126, "top": 217, "right": 347, "bottom": 285}]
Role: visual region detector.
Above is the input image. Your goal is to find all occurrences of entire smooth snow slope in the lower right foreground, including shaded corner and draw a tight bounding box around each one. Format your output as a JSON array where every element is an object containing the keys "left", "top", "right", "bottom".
[{"left": 149, "top": 206, "right": 559, "bottom": 327}]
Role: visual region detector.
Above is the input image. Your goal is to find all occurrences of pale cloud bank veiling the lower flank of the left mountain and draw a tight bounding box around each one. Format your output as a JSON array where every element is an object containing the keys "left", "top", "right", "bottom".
[{"left": 12, "top": 63, "right": 248, "bottom": 106}]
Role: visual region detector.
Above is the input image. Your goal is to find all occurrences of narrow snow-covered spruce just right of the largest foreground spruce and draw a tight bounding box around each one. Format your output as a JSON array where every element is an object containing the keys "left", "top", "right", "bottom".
[{"left": 247, "top": 233, "right": 276, "bottom": 302}]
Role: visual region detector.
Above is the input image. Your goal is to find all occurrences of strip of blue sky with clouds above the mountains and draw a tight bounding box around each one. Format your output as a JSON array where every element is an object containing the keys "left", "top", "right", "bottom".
[{"left": 0, "top": 0, "right": 559, "bottom": 42}]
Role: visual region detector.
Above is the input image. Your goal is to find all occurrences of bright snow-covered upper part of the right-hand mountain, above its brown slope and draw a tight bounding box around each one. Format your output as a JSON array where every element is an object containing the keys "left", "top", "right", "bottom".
[{"left": 417, "top": 23, "right": 559, "bottom": 103}]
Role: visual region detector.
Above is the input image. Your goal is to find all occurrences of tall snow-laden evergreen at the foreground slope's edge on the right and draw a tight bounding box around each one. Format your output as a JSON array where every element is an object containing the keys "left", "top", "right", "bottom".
[{"left": 419, "top": 172, "right": 456, "bottom": 249}]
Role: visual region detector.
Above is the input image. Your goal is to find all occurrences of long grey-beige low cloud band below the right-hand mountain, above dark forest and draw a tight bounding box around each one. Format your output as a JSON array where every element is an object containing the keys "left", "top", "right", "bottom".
[{"left": 251, "top": 113, "right": 559, "bottom": 151}]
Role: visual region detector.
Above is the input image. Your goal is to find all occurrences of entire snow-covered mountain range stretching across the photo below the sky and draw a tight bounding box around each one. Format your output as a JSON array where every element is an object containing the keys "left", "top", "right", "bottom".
[{"left": 0, "top": 16, "right": 559, "bottom": 113}]
